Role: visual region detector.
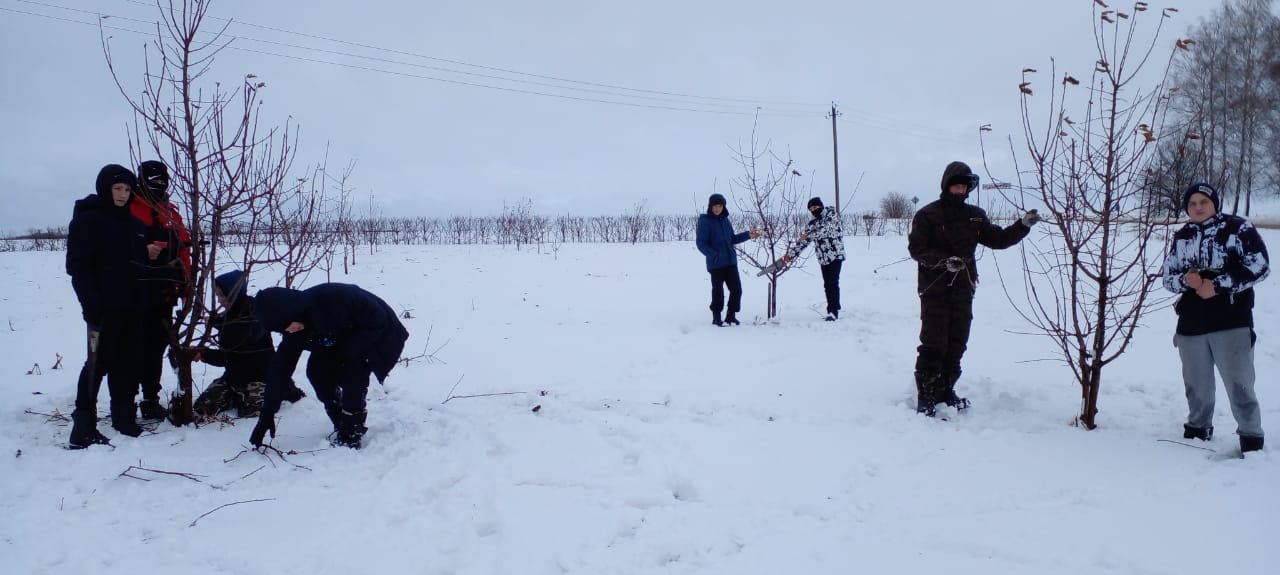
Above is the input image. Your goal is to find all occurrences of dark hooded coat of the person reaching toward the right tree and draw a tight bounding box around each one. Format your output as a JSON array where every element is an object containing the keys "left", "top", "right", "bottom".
[{"left": 908, "top": 161, "right": 1030, "bottom": 298}]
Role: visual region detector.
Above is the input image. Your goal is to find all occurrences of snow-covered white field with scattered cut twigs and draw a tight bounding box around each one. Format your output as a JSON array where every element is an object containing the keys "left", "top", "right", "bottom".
[{"left": 0, "top": 231, "right": 1280, "bottom": 575}]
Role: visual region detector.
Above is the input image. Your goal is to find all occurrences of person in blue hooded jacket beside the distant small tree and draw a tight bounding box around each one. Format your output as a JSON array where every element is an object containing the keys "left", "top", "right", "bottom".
[{"left": 696, "top": 193, "right": 759, "bottom": 325}]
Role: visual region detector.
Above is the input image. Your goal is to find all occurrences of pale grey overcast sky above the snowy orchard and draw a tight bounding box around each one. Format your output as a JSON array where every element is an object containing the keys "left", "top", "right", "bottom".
[{"left": 0, "top": 0, "right": 1220, "bottom": 232}]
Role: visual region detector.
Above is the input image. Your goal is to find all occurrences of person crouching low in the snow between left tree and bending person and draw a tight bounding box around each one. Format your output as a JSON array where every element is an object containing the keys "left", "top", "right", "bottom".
[{"left": 195, "top": 270, "right": 306, "bottom": 417}]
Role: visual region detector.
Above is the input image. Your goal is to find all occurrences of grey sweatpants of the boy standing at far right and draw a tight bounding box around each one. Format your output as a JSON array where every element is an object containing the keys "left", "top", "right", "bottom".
[{"left": 1174, "top": 328, "right": 1262, "bottom": 437}]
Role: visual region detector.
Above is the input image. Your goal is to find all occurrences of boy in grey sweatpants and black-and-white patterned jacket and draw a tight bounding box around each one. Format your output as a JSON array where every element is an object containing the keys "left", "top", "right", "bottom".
[{"left": 1164, "top": 183, "right": 1271, "bottom": 453}]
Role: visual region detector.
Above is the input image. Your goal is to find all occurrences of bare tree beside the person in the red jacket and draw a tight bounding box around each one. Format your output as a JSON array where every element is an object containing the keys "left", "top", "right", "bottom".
[{"left": 100, "top": 0, "right": 309, "bottom": 425}]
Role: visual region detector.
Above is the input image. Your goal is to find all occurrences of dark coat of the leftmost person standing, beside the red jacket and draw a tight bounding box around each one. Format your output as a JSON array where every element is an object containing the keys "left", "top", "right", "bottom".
[{"left": 67, "top": 165, "right": 147, "bottom": 325}]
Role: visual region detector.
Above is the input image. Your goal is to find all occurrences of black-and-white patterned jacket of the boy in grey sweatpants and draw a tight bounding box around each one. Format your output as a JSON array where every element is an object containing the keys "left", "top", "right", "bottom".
[{"left": 1164, "top": 214, "right": 1271, "bottom": 336}]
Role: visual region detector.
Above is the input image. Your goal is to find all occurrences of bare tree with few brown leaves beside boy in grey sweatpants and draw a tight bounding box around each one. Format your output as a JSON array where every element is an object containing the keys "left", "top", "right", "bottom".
[{"left": 997, "top": 3, "right": 1187, "bottom": 429}]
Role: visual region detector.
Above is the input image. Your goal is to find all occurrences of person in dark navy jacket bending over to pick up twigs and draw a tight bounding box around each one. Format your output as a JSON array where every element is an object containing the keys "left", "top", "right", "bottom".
[{"left": 250, "top": 283, "right": 408, "bottom": 448}]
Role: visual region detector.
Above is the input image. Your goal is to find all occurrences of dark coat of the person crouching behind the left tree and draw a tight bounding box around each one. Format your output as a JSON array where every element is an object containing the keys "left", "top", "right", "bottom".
[{"left": 201, "top": 296, "right": 275, "bottom": 387}]
